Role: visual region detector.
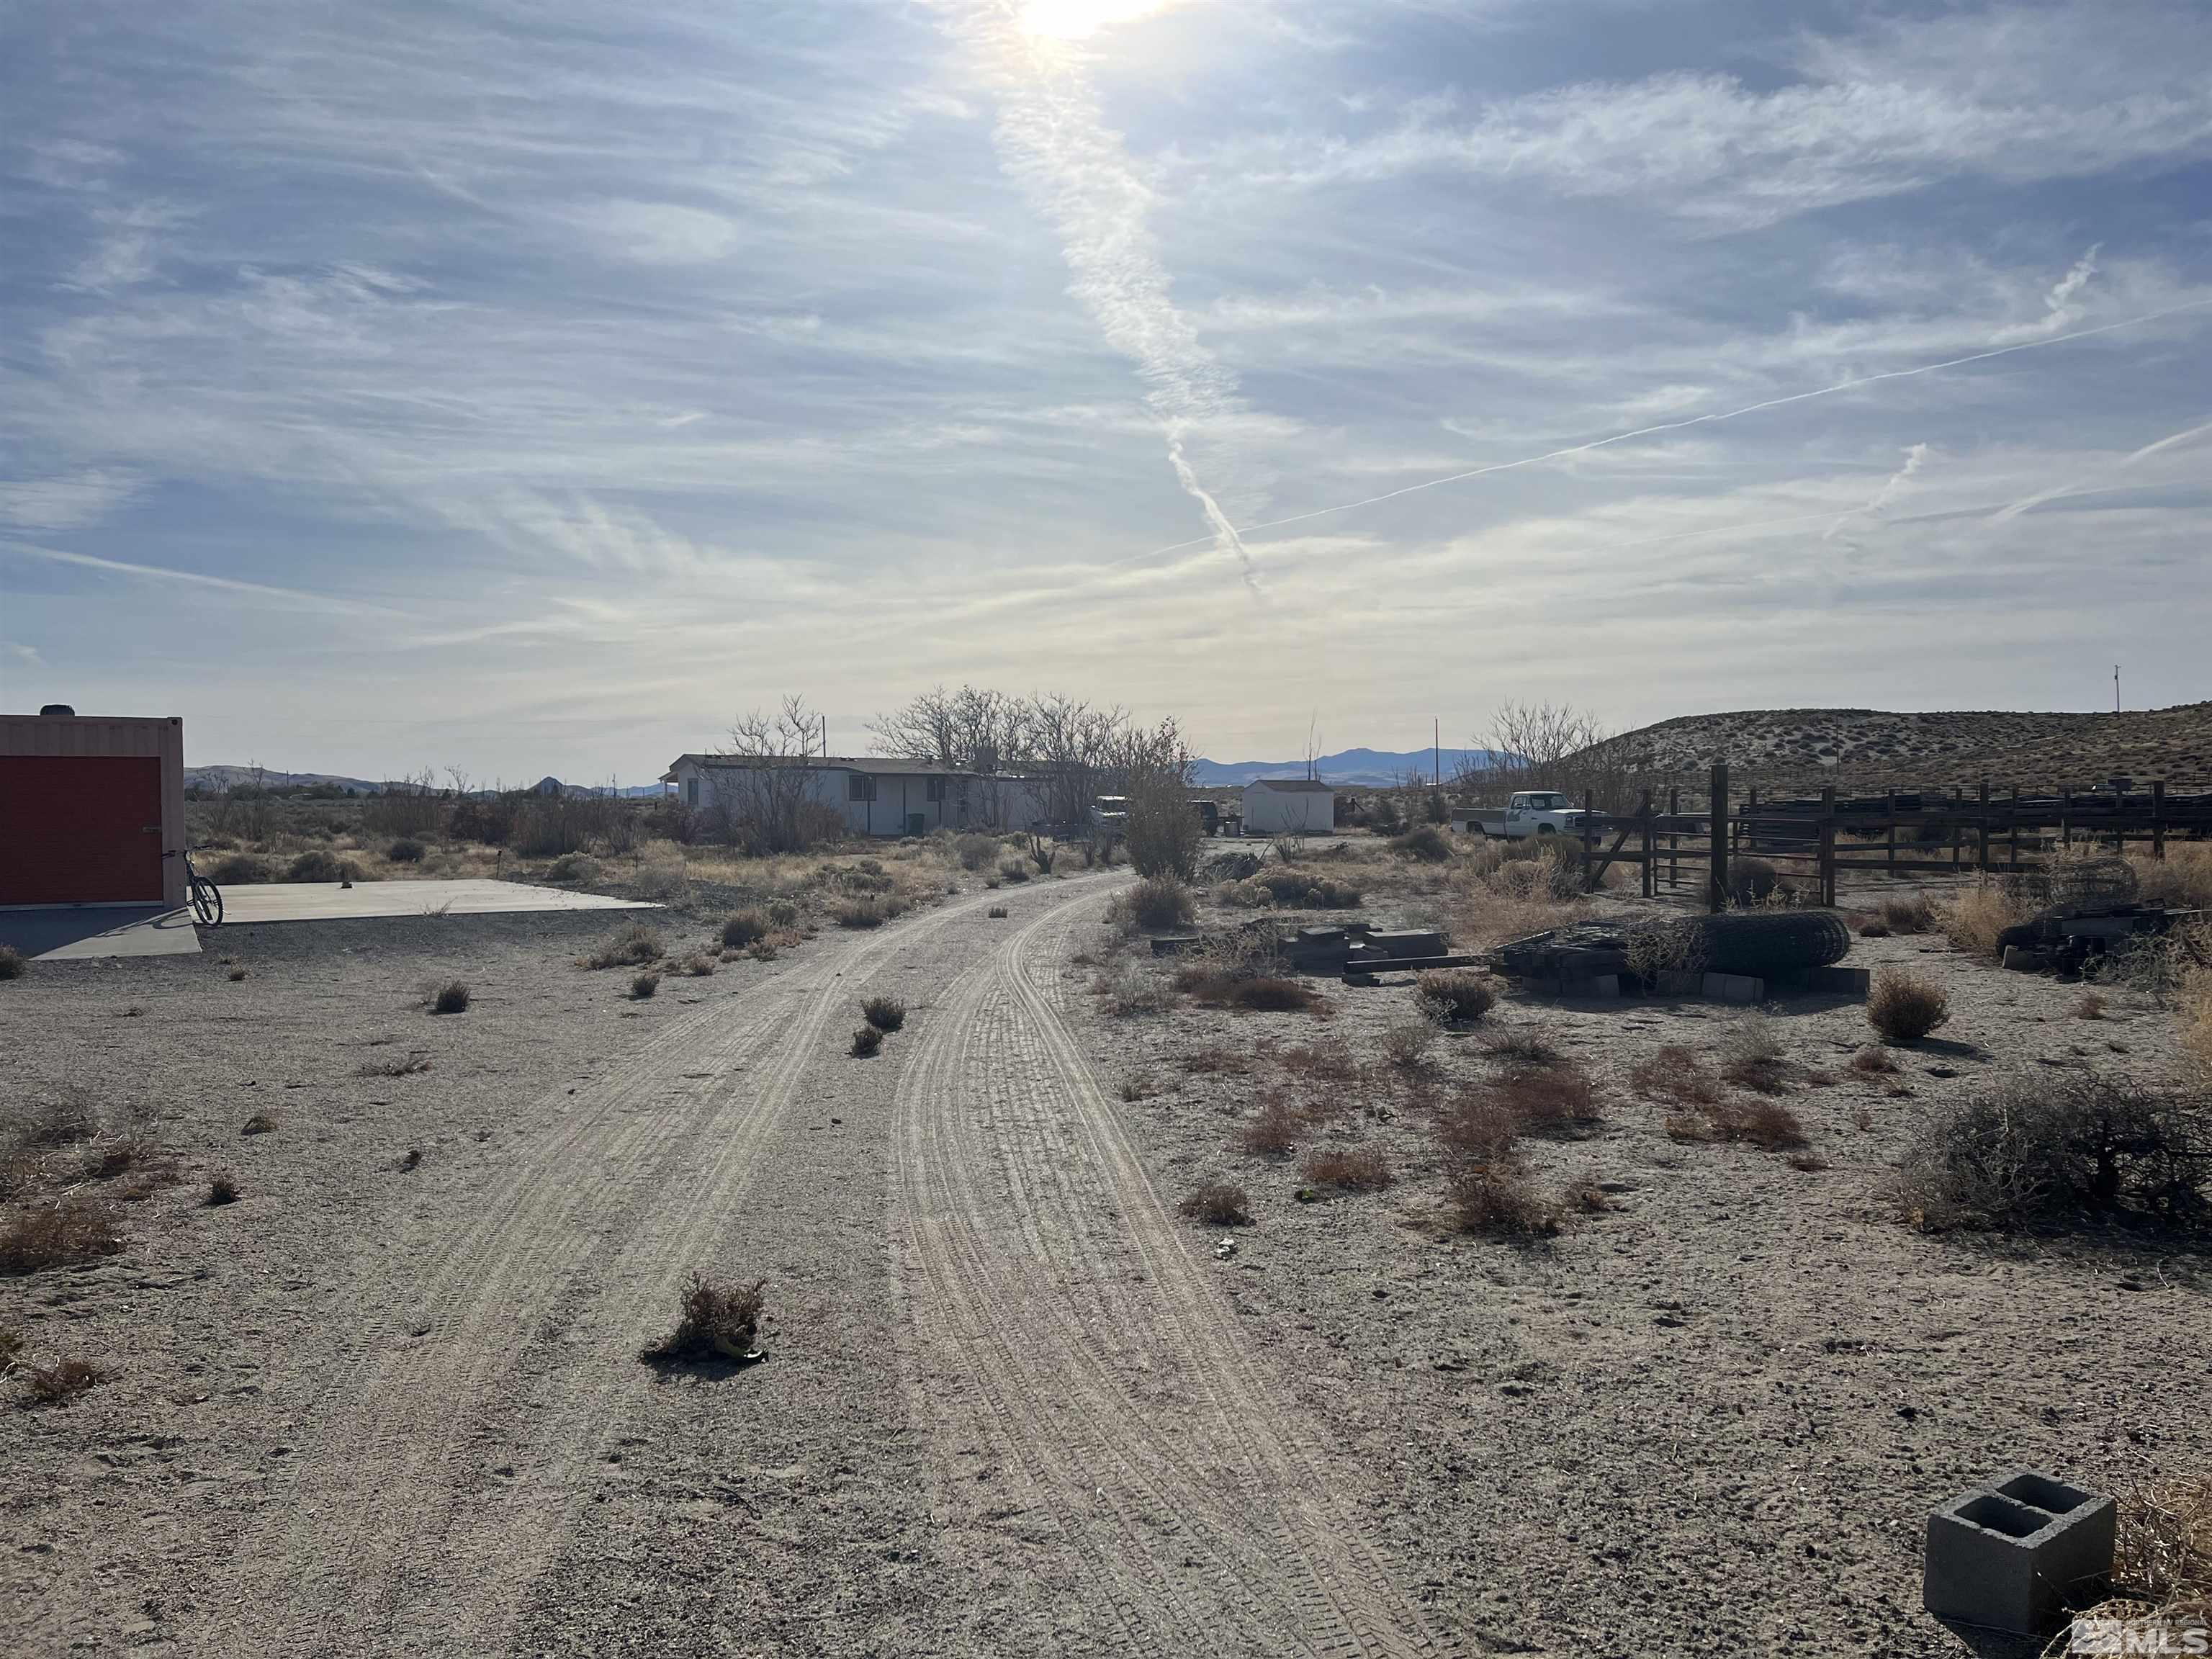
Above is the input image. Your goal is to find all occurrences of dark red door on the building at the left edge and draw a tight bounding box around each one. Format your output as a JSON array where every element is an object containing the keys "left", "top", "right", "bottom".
[{"left": 0, "top": 755, "right": 161, "bottom": 904}]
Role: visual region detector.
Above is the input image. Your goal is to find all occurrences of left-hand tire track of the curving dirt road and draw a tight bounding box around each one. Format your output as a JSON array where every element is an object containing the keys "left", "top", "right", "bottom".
[{"left": 202, "top": 896, "right": 1048, "bottom": 1655}]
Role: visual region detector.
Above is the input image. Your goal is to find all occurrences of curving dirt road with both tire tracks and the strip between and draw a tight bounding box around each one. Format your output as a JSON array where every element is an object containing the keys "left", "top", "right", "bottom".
[{"left": 107, "top": 881, "right": 1434, "bottom": 1655}]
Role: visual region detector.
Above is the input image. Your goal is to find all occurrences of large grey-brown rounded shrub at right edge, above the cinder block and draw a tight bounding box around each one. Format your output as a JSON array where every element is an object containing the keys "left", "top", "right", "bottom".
[{"left": 1898, "top": 1073, "right": 2212, "bottom": 1230}]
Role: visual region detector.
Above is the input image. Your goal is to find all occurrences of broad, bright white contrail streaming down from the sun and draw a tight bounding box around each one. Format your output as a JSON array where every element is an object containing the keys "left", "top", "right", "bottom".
[{"left": 966, "top": 2, "right": 1259, "bottom": 593}]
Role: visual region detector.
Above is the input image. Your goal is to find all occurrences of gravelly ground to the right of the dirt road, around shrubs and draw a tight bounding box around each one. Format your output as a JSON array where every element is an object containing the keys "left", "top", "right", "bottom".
[{"left": 1069, "top": 898, "right": 2212, "bottom": 1655}]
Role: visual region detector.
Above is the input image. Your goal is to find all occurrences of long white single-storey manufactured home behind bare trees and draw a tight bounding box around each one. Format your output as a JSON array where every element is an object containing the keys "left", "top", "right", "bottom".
[{"left": 662, "top": 755, "right": 1044, "bottom": 836}]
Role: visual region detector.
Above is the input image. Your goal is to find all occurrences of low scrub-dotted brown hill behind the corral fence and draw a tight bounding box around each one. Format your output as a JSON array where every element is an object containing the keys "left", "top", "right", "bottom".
[{"left": 1617, "top": 703, "right": 2212, "bottom": 792}]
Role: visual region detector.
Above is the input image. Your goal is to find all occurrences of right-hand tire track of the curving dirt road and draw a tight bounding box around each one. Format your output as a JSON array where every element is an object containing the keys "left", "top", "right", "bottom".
[{"left": 894, "top": 900, "right": 1438, "bottom": 1659}]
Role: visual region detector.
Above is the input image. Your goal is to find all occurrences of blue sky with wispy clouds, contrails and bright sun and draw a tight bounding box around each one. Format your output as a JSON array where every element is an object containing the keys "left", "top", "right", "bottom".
[{"left": 0, "top": 0, "right": 2212, "bottom": 783}]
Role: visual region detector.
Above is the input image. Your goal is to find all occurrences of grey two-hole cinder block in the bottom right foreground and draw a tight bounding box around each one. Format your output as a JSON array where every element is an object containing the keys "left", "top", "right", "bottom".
[{"left": 1920, "top": 1469, "right": 2117, "bottom": 1637}]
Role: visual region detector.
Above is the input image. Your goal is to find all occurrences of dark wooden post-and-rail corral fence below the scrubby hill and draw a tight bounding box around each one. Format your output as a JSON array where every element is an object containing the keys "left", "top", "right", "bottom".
[{"left": 1581, "top": 763, "right": 2212, "bottom": 909}]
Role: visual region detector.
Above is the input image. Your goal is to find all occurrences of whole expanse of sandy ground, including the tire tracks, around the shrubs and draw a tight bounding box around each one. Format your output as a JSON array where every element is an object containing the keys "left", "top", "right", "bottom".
[{"left": 0, "top": 858, "right": 2212, "bottom": 1657}]
